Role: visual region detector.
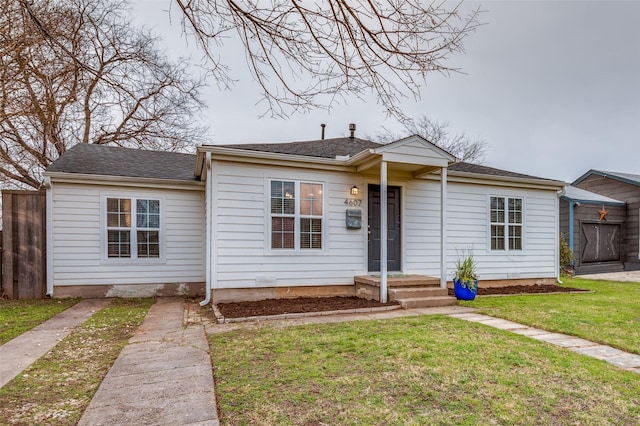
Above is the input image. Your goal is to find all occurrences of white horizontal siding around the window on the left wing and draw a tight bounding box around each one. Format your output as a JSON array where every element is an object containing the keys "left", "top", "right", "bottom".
[{"left": 52, "top": 182, "right": 205, "bottom": 286}]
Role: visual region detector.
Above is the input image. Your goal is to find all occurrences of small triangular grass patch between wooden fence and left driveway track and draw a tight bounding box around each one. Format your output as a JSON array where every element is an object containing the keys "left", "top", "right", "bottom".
[{"left": 0, "top": 299, "right": 80, "bottom": 345}]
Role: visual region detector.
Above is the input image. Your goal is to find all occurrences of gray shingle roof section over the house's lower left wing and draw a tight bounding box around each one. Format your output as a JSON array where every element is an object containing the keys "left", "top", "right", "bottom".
[{"left": 47, "top": 144, "right": 197, "bottom": 181}]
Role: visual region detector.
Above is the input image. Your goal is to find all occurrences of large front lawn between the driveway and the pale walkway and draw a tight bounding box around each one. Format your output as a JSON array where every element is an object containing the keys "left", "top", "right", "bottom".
[{"left": 209, "top": 316, "right": 640, "bottom": 425}]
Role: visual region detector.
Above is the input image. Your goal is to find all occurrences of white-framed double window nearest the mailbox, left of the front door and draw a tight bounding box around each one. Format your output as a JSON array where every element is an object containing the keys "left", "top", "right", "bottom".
[{"left": 271, "top": 180, "right": 323, "bottom": 250}]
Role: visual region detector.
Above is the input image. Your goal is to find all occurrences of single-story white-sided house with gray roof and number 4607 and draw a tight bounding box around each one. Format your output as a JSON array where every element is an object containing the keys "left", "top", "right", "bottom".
[{"left": 45, "top": 132, "right": 564, "bottom": 302}]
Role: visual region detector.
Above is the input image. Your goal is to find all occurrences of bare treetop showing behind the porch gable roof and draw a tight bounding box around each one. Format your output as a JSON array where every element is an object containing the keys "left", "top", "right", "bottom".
[{"left": 370, "top": 115, "right": 488, "bottom": 164}]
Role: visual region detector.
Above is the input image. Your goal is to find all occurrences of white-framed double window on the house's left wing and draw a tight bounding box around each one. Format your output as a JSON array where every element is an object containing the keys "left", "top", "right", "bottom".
[{"left": 107, "top": 198, "right": 160, "bottom": 259}]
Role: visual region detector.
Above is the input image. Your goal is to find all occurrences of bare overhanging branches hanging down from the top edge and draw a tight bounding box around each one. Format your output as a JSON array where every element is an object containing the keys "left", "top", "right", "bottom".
[{"left": 175, "top": 0, "right": 479, "bottom": 117}]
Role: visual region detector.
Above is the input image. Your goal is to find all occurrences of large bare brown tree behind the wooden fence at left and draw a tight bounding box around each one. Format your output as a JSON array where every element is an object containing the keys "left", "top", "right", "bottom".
[{"left": 0, "top": 0, "right": 204, "bottom": 188}]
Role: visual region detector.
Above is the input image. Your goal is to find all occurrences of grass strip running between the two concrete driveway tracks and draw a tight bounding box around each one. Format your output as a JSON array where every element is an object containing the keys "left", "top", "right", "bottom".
[{"left": 0, "top": 299, "right": 153, "bottom": 425}]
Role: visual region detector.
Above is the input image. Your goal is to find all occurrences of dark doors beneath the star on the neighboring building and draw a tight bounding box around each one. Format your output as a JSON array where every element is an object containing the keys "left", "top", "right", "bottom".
[{"left": 580, "top": 223, "right": 620, "bottom": 263}]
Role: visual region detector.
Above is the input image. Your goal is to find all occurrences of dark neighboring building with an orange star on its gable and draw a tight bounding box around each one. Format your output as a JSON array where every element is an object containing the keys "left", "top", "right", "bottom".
[{"left": 560, "top": 170, "right": 640, "bottom": 274}]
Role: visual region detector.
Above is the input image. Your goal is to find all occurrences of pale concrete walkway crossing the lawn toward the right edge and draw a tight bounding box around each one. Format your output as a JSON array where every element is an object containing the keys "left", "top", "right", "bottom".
[{"left": 449, "top": 313, "right": 640, "bottom": 374}]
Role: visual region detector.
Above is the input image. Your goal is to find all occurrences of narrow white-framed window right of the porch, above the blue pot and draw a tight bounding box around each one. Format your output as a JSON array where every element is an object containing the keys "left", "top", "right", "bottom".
[{"left": 491, "top": 197, "right": 522, "bottom": 250}]
